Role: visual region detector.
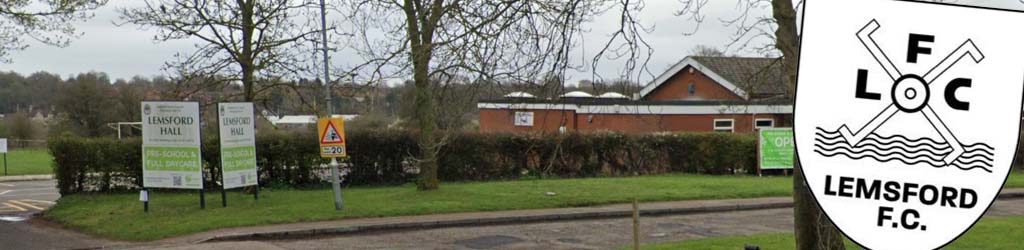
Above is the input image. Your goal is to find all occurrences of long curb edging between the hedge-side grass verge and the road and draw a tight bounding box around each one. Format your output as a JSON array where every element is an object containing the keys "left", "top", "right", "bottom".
[{"left": 194, "top": 191, "right": 1024, "bottom": 244}]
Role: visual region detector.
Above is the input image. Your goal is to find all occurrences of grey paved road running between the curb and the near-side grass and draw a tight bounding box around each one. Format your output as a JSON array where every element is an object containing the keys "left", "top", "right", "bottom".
[{"left": 249, "top": 200, "right": 1024, "bottom": 250}]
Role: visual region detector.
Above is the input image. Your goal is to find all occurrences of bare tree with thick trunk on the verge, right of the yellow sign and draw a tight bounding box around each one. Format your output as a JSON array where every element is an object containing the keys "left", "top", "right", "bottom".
[{"left": 343, "top": 0, "right": 643, "bottom": 190}]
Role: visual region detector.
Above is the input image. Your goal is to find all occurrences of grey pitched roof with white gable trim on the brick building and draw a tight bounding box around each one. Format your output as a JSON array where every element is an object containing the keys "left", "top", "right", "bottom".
[{"left": 640, "top": 56, "right": 786, "bottom": 98}]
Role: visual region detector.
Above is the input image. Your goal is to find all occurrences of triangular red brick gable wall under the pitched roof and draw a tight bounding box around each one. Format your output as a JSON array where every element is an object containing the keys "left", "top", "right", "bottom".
[{"left": 644, "top": 67, "right": 742, "bottom": 100}]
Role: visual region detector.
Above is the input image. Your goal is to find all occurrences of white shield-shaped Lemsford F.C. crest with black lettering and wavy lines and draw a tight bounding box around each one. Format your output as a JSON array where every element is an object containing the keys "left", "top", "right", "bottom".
[{"left": 794, "top": 0, "right": 1024, "bottom": 249}]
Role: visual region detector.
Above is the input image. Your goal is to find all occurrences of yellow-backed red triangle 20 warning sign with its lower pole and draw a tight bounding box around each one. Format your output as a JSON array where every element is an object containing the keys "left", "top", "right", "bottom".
[{"left": 316, "top": 118, "right": 348, "bottom": 210}]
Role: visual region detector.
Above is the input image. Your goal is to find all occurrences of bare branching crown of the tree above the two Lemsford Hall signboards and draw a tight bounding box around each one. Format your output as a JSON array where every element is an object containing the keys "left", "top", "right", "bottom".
[{"left": 121, "top": 0, "right": 319, "bottom": 101}]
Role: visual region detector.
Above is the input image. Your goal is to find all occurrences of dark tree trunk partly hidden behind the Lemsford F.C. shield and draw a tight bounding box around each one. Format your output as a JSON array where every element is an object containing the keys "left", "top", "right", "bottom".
[{"left": 772, "top": 0, "right": 846, "bottom": 247}]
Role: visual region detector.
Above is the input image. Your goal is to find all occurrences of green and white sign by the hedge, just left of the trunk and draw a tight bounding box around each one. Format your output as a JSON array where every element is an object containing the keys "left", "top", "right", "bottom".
[{"left": 758, "top": 128, "right": 795, "bottom": 176}]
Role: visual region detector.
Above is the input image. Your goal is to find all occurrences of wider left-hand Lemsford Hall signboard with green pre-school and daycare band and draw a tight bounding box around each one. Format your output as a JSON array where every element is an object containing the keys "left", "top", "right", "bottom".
[{"left": 142, "top": 101, "right": 203, "bottom": 190}]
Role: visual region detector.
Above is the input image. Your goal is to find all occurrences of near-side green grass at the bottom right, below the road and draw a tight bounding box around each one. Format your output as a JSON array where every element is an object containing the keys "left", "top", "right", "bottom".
[{"left": 643, "top": 217, "right": 1024, "bottom": 250}]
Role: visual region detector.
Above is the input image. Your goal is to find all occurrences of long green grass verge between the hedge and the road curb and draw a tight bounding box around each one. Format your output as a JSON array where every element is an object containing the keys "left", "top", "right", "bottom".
[{"left": 44, "top": 175, "right": 793, "bottom": 241}]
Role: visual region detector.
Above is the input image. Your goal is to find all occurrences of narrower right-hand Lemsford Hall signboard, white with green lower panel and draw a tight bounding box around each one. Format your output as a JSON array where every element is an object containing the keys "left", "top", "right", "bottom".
[{"left": 217, "top": 102, "right": 257, "bottom": 189}]
